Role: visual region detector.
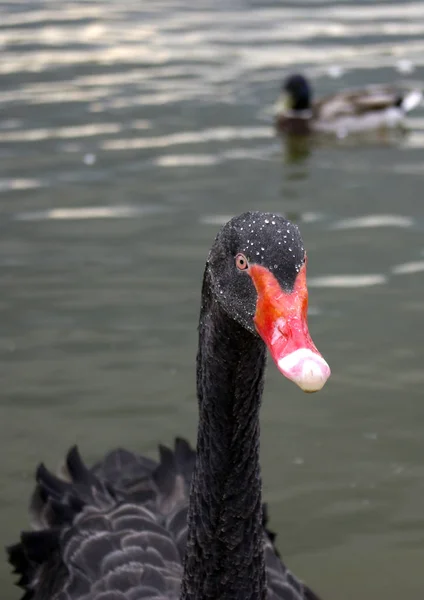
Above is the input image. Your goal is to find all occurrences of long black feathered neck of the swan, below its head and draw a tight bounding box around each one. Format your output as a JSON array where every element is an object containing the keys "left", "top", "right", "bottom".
[{"left": 181, "top": 271, "right": 266, "bottom": 600}]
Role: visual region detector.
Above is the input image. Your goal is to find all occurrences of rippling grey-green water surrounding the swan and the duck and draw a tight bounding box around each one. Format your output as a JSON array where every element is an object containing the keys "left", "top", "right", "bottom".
[{"left": 0, "top": 0, "right": 424, "bottom": 600}]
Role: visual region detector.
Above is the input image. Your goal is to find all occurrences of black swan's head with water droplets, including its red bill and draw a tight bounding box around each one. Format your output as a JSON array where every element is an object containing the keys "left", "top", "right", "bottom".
[{"left": 206, "top": 212, "right": 331, "bottom": 392}]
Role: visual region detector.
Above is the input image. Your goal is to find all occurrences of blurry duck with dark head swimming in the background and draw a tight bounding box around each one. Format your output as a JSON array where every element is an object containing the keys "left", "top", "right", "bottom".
[{"left": 275, "top": 73, "right": 422, "bottom": 138}]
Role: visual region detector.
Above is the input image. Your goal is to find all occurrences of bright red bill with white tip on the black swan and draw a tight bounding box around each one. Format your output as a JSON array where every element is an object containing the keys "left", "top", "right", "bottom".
[{"left": 249, "top": 262, "right": 331, "bottom": 392}]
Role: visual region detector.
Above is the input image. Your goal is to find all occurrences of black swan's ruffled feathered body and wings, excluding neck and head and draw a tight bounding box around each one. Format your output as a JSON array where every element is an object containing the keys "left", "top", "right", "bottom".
[{"left": 8, "top": 438, "right": 319, "bottom": 600}]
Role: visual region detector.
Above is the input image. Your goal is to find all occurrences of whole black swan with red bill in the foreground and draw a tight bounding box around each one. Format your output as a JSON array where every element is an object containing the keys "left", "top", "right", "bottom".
[{"left": 8, "top": 212, "right": 330, "bottom": 600}]
